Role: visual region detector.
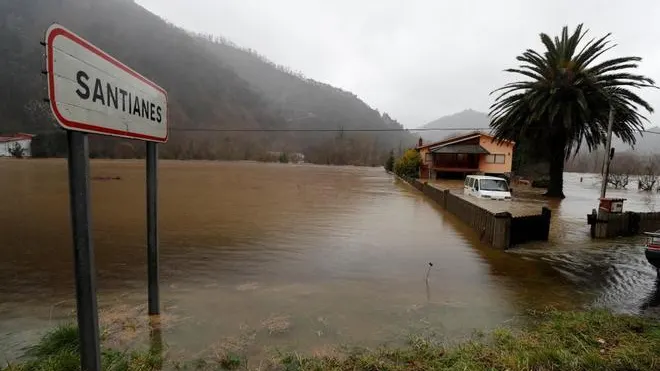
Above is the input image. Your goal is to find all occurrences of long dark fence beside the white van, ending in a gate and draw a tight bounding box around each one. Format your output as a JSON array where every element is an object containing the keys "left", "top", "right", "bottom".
[{"left": 404, "top": 178, "right": 550, "bottom": 249}]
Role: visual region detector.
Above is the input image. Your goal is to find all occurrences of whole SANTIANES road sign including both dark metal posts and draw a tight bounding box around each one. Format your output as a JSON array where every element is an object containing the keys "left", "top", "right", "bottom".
[{"left": 42, "top": 24, "right": 169, "bottom": 371}]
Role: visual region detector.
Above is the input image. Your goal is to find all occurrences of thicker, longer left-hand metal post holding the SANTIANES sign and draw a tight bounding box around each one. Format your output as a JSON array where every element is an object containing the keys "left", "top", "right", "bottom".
[{"left": 67, "top": 131, "right": 101, "bottom": 371}]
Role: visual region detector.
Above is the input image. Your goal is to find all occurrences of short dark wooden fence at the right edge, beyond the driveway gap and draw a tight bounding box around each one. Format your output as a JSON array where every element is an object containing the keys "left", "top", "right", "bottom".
[{"left": 587, "top": 210, "right": 660, "bottom": 238}]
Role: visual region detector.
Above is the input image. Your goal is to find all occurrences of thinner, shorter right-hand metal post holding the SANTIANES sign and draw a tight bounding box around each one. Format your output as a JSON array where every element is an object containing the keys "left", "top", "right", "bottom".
[{"left": 147, "top": 142, "right": 160, "bottom": 315}]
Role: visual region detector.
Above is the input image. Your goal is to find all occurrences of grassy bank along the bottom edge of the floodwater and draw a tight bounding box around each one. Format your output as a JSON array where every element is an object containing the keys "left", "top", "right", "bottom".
[{"left": 2, "top": 311, "right": 660, "bottom": 371}]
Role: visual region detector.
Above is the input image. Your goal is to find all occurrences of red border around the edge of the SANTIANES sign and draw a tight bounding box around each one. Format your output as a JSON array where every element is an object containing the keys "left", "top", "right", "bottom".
[{"left": 46, "top": 24, "right": 169, "bottom": 143}]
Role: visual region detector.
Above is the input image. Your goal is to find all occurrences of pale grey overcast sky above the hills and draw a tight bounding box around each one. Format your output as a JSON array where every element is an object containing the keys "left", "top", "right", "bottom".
[{"left": 137, "top": 0, "right": 660, "bottom": 127}]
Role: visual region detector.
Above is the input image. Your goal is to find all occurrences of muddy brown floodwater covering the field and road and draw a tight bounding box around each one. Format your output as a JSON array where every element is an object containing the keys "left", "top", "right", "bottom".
[{"left": 0, "top": 160, "right": 659, "bottom": 359}]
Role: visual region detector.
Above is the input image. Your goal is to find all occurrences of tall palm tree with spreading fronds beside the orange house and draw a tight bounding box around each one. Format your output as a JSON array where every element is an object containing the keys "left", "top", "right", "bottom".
[{"left": 490, "top": 24, "right": 655, "bottom": 198}]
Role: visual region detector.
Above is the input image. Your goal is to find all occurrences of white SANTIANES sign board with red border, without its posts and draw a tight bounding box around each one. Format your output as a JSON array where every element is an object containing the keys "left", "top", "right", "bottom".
[{"left": 46, "top": 24, "right": 168, "bottom": 142}]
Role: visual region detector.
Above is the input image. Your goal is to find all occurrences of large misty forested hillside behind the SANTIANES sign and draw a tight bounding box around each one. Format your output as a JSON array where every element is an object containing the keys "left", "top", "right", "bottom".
[{"left": 0, "top": 0, "right": 414, "bottom": 165}]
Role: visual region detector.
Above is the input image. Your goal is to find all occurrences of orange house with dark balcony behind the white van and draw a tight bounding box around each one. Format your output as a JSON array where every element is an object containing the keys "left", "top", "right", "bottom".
[{"left": 416, "top": 131, "right": 515, "bottom": 179}]
